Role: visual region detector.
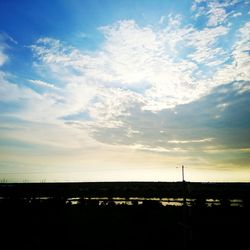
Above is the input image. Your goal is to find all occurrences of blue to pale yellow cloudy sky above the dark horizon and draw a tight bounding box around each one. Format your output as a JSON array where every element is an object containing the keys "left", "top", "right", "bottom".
[{"left": 0, "top": 0, "right": 250, "bottom": 182}]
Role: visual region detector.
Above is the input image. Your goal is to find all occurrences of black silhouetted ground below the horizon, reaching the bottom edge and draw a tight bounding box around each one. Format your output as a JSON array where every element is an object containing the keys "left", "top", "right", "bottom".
[{"left": 0, "top": 183, "right": 250, "bottom": 249}]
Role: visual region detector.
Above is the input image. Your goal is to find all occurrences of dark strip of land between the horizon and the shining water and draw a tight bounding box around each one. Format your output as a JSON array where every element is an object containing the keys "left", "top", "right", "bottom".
[{"left": 0, "top": 182, "right": 250, "bottom": 199}]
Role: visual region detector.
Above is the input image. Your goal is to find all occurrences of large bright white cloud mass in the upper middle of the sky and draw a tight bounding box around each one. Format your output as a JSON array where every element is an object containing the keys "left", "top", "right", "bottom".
[{"left": 25, "top": 15, "right": 246, "bottom": 127}]
